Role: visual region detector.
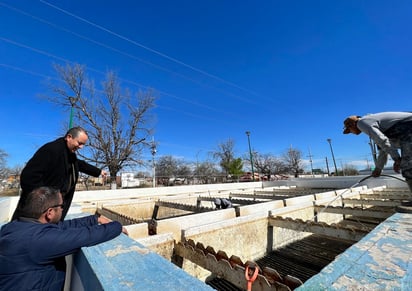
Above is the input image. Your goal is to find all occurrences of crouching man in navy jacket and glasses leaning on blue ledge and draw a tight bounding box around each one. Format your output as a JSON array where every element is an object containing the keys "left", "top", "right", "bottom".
[{"left": 0, "top": 187, "right": 122, "bottom": 291}]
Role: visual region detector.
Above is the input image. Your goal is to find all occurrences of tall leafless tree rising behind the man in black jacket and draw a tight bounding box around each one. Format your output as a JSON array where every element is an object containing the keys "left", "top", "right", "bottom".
[{"left": 48, "top": 64, "right": 155, "bottom": 182}]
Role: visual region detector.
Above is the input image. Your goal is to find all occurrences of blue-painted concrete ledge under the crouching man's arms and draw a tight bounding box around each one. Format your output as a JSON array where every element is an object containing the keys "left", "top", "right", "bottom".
[{"left": 74, "top": 234, "right": 214, "bottom": 291}]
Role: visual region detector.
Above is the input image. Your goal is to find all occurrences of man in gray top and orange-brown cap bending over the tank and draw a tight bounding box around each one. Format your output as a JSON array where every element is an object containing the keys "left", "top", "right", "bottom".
[{"left": 343, "top": 112, "right": 412, "bottom": 196}]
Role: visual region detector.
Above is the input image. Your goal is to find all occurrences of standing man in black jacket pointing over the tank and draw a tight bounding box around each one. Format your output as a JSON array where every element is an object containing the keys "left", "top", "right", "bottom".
[{"left": 12, "top": 127, "right": 106, "bottom": 221}]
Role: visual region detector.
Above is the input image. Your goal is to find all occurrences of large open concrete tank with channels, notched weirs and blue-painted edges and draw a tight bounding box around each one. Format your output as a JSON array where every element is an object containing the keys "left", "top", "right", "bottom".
[{"left": 0, "top": 176, "right": 412, "bottom": 290}]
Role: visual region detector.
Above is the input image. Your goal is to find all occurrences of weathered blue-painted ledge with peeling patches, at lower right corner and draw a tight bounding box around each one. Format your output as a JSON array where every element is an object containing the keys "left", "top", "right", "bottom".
[{"left": 296, "top": 213, "right": 412, "bottom": 291}]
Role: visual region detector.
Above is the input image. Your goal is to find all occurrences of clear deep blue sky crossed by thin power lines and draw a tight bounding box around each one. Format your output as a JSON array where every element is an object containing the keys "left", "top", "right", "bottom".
[{"left": 0, "top": 0, "right": 412, "bottom": 173}]
